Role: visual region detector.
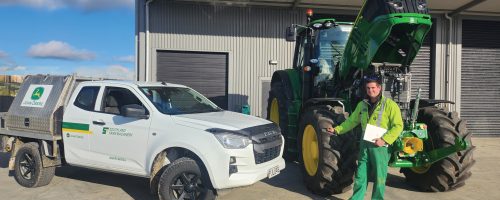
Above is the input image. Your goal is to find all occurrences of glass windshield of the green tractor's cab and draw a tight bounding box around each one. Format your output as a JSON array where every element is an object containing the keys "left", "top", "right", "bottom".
[{"left": 316, "top": 25, "right": 352, "bottom": 69}]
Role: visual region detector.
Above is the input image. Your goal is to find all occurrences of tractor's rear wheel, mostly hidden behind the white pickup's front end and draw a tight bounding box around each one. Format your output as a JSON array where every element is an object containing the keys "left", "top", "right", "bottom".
[{"left": 267, "top": 82, "right": 297, "bottom": 161}]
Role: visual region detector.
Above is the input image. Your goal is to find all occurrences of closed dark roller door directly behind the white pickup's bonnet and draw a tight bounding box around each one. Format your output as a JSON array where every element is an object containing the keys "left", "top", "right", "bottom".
[{"left": 156, "top": 51, "right": 228, "bottom": 109}]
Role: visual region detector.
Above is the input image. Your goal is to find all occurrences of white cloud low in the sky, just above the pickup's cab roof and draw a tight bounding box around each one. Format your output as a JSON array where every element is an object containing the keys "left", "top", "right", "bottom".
[{"left": 75, "top": 65, "right": 135, "bottom": 80}]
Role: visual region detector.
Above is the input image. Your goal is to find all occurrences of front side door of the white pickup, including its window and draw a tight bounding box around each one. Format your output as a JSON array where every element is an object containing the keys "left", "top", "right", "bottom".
[{"left": 90, "top": 86, "right": 151, "bottom": 175}]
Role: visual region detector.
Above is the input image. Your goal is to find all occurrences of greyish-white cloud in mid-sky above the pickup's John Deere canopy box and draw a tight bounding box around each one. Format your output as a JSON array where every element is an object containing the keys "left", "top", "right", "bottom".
[{"left": 28, "top": 40, "right": 95, "bottom": 60}]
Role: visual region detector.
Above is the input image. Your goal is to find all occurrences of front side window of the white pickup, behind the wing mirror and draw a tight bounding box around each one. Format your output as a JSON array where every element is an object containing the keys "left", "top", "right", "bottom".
[{"left": 101, "top": 87, "right": 147, "bottom": 115}]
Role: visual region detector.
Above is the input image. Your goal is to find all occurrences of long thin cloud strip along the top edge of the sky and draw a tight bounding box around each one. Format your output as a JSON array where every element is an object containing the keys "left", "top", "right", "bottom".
[{"left": 0, "top": 0, "right": 134, "bottom": 11}]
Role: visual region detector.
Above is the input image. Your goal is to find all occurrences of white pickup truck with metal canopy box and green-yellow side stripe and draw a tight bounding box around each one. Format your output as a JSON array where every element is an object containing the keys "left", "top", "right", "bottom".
[{"left": 0, "top": 75, "right": 285, "bottom": 199}]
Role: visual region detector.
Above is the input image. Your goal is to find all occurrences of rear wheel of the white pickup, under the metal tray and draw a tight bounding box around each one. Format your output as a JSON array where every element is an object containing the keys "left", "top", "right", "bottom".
[{"left": 14, "top": 142, "right": 55, "bottom": 188}]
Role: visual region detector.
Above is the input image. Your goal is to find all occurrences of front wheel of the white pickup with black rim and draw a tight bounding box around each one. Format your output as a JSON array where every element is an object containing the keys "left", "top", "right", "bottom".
[{"left": 158, "top": 157, "right": 215, "bottom": 200}]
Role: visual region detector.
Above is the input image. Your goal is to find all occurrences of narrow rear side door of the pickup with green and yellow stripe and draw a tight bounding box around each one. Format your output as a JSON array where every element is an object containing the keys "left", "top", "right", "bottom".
[{"left": 62, "top": 86, "right": 100, "bottom": 165}]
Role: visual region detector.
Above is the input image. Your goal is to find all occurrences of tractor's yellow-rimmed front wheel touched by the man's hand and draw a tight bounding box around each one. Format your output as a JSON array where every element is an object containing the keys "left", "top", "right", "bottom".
[{"left": 298, "top": 106, "right": 359, "bottom": 196}]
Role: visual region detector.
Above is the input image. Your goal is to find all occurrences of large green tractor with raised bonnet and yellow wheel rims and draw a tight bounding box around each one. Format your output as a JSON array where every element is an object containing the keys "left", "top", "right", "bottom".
[{"left": 267, "top": 0, "right": 475, "bottom": 195}]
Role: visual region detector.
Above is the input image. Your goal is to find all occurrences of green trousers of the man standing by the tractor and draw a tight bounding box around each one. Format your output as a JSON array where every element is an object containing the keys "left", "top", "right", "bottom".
[{"left": 350, "top": 140, "right": 389, "bottom": 200}]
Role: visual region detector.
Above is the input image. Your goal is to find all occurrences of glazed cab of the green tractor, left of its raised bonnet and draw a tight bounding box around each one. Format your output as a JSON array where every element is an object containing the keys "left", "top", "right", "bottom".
[{"left": 286, "top": 19, "right": 353, "bottom": 99}]
